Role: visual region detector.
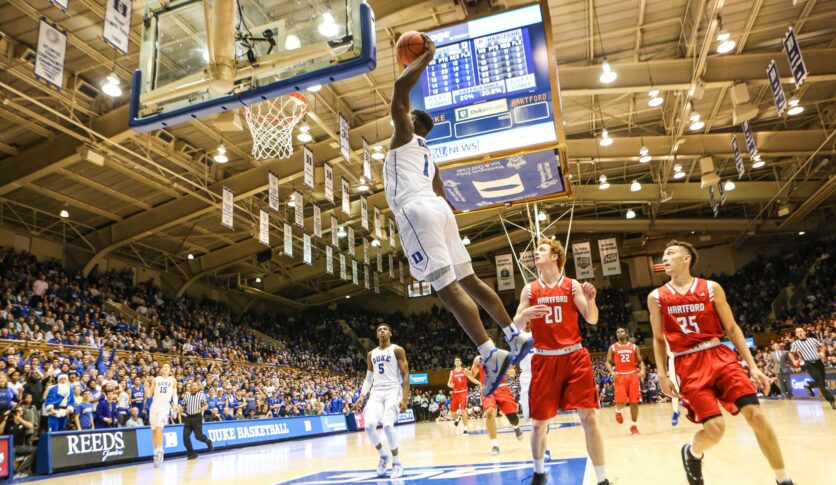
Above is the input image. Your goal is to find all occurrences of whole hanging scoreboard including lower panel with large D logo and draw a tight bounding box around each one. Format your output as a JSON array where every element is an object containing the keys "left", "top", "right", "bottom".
[{"left": 410, "top": 4, "right": 571, "bottom": 210}]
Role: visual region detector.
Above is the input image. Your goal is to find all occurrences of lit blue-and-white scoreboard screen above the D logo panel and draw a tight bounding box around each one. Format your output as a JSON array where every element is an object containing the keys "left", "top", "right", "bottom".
[{"left": 410, "top": 5, "right": 559, "bottom": 164}]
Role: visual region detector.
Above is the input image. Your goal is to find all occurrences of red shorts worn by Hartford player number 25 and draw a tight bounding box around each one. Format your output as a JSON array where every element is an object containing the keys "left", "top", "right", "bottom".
[{"left": 675, "top": 345, "right": 757, "bottom": 423}]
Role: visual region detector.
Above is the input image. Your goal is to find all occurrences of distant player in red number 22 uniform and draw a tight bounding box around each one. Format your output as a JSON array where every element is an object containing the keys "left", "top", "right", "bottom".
[{"left": 606, "top": 328, "right": 645, "bottom": 434}]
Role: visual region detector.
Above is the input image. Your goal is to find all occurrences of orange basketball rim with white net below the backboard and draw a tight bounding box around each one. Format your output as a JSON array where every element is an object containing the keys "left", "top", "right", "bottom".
[{"left": 244, "top": 93, "right": 308, "bottom": 160}]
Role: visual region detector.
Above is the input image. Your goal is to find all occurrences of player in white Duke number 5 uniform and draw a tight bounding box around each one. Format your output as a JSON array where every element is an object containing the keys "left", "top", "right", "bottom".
[{"left": 358, "top": 323, "right": 409, "bottom": 478}]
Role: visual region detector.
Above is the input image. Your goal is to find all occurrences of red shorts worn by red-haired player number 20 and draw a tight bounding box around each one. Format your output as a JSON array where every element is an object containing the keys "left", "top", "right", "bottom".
[{"left": 528, "top": 349, "right": 598, "bottom": 420}]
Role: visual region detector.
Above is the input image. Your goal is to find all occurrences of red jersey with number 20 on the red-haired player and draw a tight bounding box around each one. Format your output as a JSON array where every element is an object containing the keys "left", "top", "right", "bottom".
[{"left": 524, "top": 276, "right": 581, "bottom": 350}]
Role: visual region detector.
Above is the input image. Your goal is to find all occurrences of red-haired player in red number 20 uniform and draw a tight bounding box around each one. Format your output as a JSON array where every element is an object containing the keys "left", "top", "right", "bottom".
[{"left": 514, "top": 239, "right": 610, "bottom": 485}]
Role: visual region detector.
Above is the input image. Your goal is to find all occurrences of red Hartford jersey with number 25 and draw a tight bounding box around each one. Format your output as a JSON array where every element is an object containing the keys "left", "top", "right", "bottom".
[{"left": 650, "top": 278, "right": 725, "bottom": 352}]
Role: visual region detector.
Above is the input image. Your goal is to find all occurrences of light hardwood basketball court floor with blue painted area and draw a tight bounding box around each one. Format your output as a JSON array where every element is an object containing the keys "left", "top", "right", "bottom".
[{"left": 29, "top": 401, "right": 836, "bottom": 485}]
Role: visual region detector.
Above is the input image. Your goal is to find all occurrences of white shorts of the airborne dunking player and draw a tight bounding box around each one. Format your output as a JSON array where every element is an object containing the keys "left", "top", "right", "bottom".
[{"left": 395, "top": 197, "right": 473, "bottom": 291}]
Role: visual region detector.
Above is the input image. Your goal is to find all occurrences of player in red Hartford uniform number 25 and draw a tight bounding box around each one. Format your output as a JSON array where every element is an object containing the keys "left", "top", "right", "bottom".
[{"left": 647, "top": 241, "right": 792, "bottom": 485}]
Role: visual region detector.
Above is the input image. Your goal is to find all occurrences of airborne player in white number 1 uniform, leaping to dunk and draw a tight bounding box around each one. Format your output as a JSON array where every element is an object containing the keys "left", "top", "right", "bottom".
[{"left": 383, "top": 35, "right": 532, "bottom": 396}]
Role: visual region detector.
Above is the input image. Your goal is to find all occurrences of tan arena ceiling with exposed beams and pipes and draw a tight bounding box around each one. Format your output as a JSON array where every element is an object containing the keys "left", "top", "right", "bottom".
[{"left": 0, "top": 0, "right": 836, "bottom": 306}]
